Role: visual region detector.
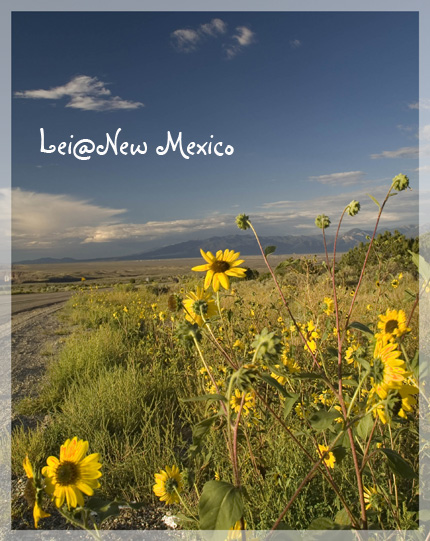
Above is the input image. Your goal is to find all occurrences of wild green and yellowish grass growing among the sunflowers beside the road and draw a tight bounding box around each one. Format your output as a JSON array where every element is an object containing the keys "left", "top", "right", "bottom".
[{"left": 12, "top": 252, "right": 417, "bottom": 529}]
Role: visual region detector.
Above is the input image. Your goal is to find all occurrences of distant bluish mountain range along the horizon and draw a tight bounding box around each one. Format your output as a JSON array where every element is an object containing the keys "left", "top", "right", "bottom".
[{"left": 15, "top": 225, "right": 419, "bottom": 265}]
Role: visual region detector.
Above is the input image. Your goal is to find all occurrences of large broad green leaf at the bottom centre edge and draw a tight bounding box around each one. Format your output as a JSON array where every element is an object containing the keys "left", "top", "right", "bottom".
[{"left": 199, "top": 481, "right": 243, "bottom": 530}]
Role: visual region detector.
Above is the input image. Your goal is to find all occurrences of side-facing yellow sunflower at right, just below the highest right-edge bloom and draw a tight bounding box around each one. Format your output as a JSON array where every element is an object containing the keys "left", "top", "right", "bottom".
[{"left": 370, "top": 341, "right": 409, "bottom": 400}]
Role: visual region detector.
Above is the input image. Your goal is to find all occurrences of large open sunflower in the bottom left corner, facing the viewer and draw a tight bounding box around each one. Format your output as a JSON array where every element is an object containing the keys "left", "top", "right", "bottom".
[{"left": 42, "top": 436, "right": 102, "bottom": 509}]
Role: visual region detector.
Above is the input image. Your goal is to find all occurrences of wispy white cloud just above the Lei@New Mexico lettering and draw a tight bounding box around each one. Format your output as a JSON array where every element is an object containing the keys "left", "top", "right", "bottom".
[{"left": 14, "top": 75, "right": 144, "bottom": 111}]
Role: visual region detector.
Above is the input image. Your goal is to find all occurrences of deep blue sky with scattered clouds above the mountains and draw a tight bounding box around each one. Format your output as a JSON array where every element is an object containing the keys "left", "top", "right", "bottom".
[{"left": 12, "top": 12, "right": 420, "bottom": 261}]
